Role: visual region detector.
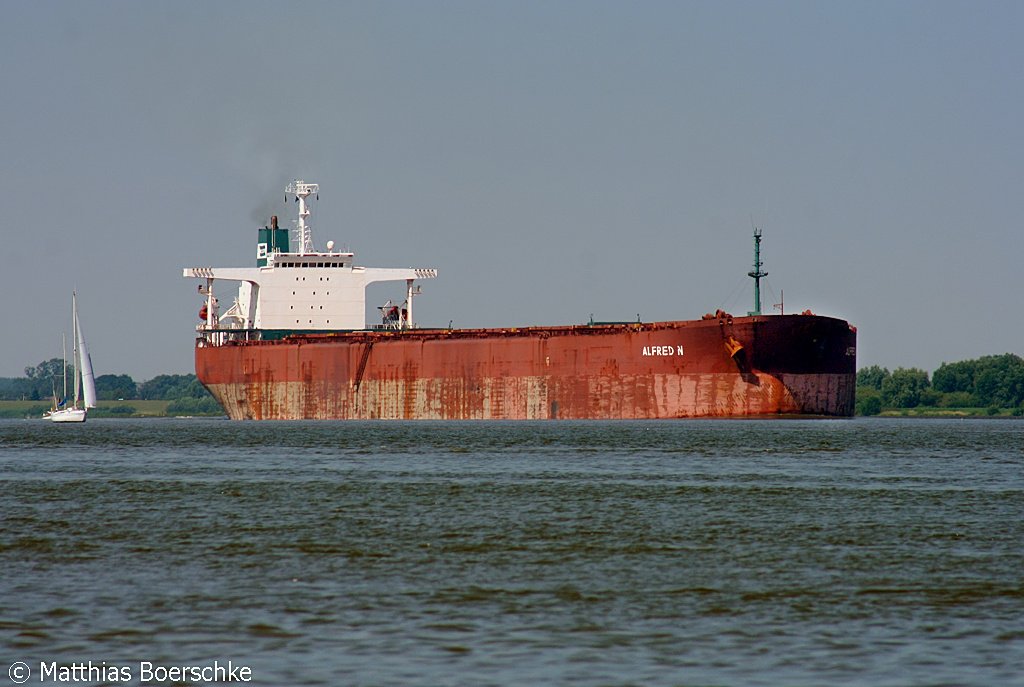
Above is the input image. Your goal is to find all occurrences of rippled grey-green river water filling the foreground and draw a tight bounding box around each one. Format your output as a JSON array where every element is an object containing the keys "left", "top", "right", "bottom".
[{"left": 0, "top": 419, "right": 1024, "bottom": 687}]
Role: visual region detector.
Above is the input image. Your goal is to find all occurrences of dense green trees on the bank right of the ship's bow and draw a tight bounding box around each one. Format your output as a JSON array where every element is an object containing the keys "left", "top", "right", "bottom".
[{"left": 857, "top": 353, "right": 1024, "bottom": 416}]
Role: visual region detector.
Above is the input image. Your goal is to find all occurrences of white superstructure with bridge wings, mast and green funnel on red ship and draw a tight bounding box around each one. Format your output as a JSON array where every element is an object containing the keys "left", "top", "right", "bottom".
[{"left": 183, "top": 179, "right": 437, "bottom": 331}]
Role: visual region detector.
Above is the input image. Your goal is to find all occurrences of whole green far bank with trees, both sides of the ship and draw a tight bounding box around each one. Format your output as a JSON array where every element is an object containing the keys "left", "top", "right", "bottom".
[{"left": 0, "top": 353, "right": 1024, "bottom": 418}]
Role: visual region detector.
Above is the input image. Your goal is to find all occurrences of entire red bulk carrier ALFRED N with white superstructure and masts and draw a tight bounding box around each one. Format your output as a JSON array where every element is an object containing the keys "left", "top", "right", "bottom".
[{"left": 184, "top": 180, "right": 856, "bottom": 420}]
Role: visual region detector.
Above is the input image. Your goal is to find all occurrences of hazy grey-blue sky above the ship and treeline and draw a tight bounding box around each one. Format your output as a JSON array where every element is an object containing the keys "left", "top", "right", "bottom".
[{"left": 0, "top": 0, "right": 1024, "bottom": 381}]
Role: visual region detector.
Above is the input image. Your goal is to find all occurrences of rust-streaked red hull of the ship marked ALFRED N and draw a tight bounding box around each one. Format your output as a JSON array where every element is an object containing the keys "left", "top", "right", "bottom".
[{"left": 196, "top": 315, "right": 856, "bottom": 420}]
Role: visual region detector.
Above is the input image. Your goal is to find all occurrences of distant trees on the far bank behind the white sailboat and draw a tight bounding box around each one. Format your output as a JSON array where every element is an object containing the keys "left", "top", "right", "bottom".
[{"left": 0, "top": 357, "right": 213, "bottom": 401}]
